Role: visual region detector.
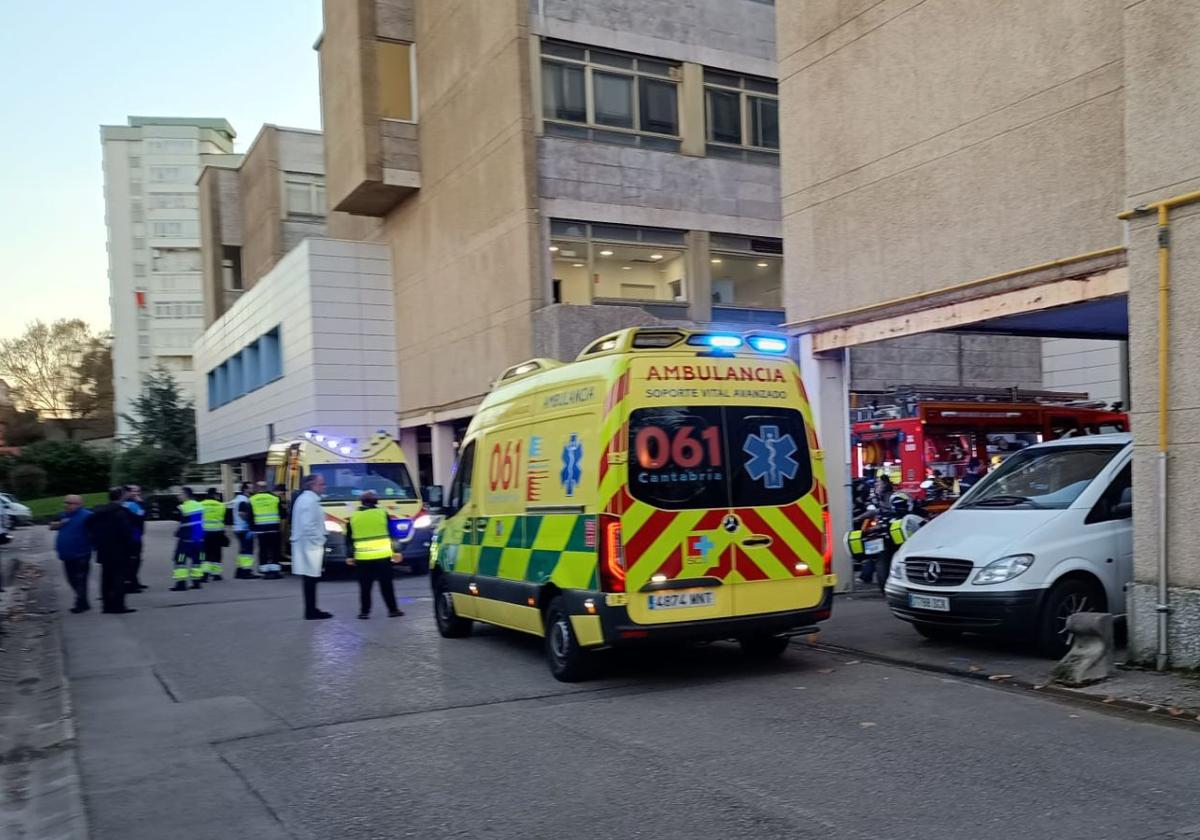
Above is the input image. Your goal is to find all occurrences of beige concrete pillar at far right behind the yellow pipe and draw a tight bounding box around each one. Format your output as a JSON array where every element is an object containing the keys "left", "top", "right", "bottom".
[{"left": 1123, "top": 0, "right": 1200, "bottom": 668}]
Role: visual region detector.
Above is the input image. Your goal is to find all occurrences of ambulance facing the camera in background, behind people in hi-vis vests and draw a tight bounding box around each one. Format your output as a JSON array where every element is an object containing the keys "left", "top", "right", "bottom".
[{"left": 266, "top": 430, "right": 436, "bottom": 574}]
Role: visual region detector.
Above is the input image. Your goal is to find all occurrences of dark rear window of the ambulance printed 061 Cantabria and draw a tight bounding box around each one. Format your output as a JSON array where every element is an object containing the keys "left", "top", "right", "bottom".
[{"left": 629, "top": 406, "right": 812, "bottom": 510}]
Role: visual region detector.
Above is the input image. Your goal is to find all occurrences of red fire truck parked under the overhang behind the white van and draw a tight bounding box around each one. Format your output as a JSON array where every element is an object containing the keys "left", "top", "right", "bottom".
[{"left": 851, "top": 391, "right": 1129, "bottom": 498}]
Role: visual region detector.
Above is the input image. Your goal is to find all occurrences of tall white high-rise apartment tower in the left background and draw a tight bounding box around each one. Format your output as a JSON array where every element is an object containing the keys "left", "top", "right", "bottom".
[{"left": 101, "top": 116, "right": 234, "bottom": 437}]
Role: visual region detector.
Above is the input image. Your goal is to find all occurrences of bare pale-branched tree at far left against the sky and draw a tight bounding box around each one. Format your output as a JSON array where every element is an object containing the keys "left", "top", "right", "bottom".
[{"left": 0, "top": 318, "right": 112, "bottom": 437}]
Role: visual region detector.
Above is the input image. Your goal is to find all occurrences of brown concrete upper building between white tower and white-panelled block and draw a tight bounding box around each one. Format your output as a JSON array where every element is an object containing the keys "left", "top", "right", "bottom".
[{"left": 198, "top": 125, "right": 328, "bottom": 326}]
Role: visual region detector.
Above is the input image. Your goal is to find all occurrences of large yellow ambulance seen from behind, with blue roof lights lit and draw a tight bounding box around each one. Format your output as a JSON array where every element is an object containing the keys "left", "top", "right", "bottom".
[{"left": 431, "top": 328, "right": 836, "bottom": 680}]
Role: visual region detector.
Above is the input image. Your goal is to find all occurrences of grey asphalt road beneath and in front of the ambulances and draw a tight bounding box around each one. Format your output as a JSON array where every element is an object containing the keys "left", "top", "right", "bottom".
[{"left": 47, "top": 526, "right": 1200, "bottom": 840}]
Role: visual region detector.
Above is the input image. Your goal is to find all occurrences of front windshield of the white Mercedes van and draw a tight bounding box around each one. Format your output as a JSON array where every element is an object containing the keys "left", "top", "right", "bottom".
[{"left": 959, "top": 444, "right": 1123, "bottom": 510}]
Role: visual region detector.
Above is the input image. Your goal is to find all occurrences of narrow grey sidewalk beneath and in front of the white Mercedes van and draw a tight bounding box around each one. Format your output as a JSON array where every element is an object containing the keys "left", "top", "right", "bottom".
[{"left": 809, "top": 593, "right": 1200, "bottom": 725}]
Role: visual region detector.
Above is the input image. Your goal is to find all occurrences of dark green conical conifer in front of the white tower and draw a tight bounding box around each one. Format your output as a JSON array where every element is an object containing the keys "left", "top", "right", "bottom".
[{"left": 116, "top": 365, "right": 196, "bottom": 490}]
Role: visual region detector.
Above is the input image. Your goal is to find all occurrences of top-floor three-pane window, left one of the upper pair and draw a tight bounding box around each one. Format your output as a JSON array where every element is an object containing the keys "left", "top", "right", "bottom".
[{"left": 541, "top": 41, "right": 679, "bottom": 151}]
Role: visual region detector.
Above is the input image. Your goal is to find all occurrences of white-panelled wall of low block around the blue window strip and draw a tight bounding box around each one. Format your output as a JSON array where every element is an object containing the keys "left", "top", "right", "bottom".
[{"left": 193, "top": 239, "right": 398, "bottom": 463}]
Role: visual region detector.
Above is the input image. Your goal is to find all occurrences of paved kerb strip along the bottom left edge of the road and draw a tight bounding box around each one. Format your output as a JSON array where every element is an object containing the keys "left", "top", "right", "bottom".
[{"left": 0, "top": 537, "right": 90, "bottom": 840}]
